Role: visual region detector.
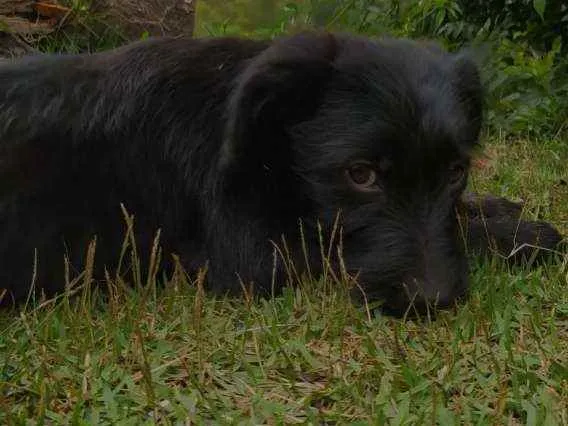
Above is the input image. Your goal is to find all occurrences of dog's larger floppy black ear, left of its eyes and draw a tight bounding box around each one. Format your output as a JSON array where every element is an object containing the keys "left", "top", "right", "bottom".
[{"left": 219, "top": 33, "right": 337, "bottom": 175}]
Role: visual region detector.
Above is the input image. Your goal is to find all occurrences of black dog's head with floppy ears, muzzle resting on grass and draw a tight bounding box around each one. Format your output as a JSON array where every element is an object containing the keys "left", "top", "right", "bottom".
[{"left": 220, "top": 34, "right": 482, "bottom": 311}]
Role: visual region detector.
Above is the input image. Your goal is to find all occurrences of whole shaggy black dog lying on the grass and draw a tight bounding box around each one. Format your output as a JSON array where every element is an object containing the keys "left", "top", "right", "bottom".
[{"left": 0, "top": 34, "right": 560, "bottom": 312}]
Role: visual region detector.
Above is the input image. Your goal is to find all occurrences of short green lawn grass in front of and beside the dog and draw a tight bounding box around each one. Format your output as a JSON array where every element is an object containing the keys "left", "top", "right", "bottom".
[{"left": 0, "top": 133, "right": 568, "bottom": 425}]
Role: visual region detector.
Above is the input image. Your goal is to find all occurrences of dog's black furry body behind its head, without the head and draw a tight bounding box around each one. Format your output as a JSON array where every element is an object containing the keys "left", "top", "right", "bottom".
[{"left": 0, "top": 38, "right": 267, "bottom": 298}]
